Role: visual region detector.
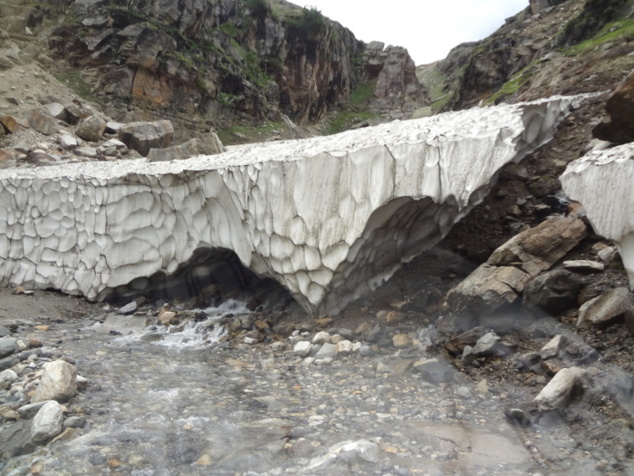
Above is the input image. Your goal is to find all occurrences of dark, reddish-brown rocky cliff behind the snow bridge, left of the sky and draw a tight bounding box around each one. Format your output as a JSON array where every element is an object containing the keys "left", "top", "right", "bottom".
[{"left": 3, "top": 0, "right": 426, "bottom": 138}]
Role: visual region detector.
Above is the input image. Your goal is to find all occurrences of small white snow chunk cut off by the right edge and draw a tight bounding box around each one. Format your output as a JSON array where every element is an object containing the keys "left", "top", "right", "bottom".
[{"left": 561, "top": 143, "right": 634, "bottom": 289}]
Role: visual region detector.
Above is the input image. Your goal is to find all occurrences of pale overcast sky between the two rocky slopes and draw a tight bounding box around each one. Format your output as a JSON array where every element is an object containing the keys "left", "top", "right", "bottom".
[{"left": 291, "top": 0, "right": 529, "bottom": 65}]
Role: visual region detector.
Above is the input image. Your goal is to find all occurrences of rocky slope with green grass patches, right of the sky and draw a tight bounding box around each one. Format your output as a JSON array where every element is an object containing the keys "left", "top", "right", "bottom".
[{"left": 421, "top": 0, "right": 634, "bottom": 110}]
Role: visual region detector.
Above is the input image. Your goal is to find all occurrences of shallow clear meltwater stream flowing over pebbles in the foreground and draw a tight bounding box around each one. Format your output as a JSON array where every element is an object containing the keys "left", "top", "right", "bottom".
[{"left": 6, "top": 301, "right": 616, "bottom": 476}]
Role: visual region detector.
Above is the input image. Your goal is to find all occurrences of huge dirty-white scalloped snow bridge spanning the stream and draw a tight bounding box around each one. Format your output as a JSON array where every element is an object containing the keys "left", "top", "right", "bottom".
[{"left": 0, "top": 97, "right": 580, "bottom": 315}]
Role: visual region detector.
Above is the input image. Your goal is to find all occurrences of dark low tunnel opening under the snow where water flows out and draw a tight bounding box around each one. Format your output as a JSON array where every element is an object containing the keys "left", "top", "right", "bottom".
[{"left": 104, "top": 248, "right": 294, "bottom": 310}]
